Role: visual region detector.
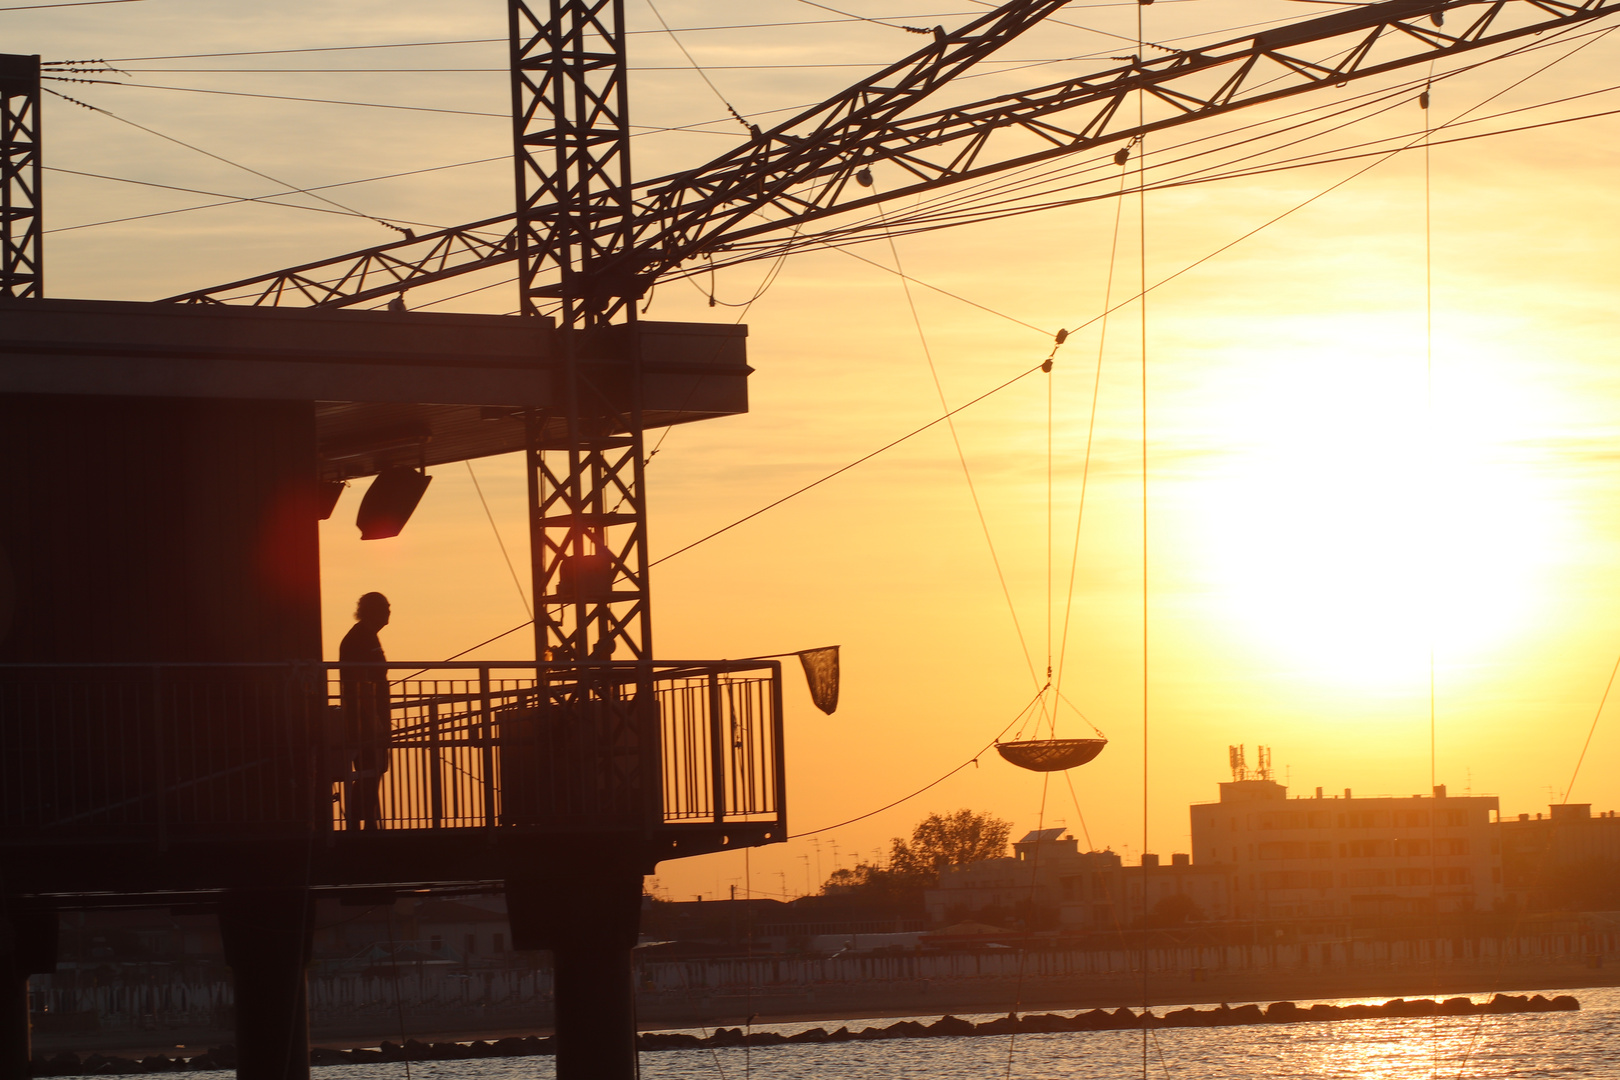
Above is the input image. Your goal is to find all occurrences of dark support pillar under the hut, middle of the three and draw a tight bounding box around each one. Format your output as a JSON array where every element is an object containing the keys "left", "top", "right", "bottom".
[{"left": 219, "top": 889, "right": 314, "bottom": 1080}]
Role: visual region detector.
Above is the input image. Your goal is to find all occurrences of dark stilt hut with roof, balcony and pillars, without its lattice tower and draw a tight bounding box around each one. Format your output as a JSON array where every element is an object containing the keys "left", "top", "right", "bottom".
[{"left": 0, "top": 300, "right": 784, "bottom": 1080}]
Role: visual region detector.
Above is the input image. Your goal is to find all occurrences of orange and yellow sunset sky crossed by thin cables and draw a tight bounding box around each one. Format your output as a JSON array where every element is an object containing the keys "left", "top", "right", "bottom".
[{"left": 12, "top": 0, "right": 1620, "bottom": 899}]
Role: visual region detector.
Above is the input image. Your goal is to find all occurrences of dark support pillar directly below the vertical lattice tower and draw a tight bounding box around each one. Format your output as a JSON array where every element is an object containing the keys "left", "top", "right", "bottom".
[{"left": 507, "top": 860, "right": 642, "bottom": 1080}]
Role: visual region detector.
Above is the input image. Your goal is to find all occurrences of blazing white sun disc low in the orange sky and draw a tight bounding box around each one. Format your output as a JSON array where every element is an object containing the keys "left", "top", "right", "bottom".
[{"left": 1191, "top": 317, "right": 1563, "bottom": 690}]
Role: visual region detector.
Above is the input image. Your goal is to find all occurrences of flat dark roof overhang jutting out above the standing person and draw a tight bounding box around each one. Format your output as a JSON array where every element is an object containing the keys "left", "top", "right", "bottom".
[{"left": 0, "top": 298, "right": 752, "bottom": 478}]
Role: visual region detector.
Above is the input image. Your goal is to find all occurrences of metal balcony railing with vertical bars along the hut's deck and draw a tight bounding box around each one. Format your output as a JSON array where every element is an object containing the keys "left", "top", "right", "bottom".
[{"left": 0, "top": 661, "right": 782, "bottom": 842}]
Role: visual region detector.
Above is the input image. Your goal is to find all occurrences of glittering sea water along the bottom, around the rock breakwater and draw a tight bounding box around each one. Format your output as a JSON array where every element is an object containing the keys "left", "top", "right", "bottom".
[{"left": 314, "top": 988, "right": 1620, "bottom": 1080}]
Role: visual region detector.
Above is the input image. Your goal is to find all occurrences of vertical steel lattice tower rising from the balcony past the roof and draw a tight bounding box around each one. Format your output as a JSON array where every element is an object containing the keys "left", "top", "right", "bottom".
[{"left": 509, "top": 0, "right": 653, "bottom": 676}]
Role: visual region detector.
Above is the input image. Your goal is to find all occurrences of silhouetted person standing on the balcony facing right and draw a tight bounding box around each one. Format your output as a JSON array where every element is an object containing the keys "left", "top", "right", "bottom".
[{"left": 337, "top": 593, "right": 389, "bottom": 829}]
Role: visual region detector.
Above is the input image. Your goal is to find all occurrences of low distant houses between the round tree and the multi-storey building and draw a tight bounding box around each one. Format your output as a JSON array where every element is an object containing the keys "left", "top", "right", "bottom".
[{"left": 927, "top": 829, "right": 1228, "bottom": 931}]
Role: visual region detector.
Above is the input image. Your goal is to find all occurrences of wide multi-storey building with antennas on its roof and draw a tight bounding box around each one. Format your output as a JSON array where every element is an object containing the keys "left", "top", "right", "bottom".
[{"left": 1191, "top": 773, "right": 1503, "bottom": 920}]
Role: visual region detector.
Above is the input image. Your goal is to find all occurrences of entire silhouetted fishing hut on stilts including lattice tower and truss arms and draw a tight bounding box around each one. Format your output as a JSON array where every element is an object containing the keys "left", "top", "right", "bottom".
[{"left": 0, "top": 0, "right": 1620, "bottom": 1080}]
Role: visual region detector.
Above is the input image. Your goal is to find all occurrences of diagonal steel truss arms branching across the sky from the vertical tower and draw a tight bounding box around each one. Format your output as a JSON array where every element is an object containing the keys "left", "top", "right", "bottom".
[{"left": 173, "top": 0, "right": 1620, "bottom": 306}]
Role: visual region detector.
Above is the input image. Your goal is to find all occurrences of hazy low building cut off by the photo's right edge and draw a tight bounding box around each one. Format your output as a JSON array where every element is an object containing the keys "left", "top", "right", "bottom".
[{"left": 1497, "top": 803, "right": 1620, "bottom": 912}]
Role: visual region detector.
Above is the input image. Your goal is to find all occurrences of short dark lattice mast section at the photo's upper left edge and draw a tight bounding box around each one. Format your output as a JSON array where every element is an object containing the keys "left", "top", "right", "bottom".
[{"left": 0, "top": 55, "right": 44, "bottom": 296}]
